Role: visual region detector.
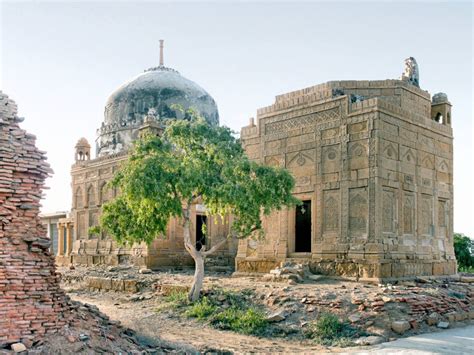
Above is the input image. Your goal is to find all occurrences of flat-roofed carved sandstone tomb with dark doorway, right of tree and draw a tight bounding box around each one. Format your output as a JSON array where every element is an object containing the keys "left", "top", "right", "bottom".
[{"left": 236, "top": 58, "right": 456, "bottom": 280}]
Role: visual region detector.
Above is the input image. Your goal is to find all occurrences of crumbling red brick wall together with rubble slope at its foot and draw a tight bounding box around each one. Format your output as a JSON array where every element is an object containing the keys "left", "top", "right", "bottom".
[{"left": 0, "top": 91, "right": 176, "bottom": 354}]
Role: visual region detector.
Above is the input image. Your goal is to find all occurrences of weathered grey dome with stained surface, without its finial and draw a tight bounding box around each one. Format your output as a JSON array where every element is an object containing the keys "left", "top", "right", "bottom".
[{"left": 97, "top": 65, "right": 219, "bottom": 156}]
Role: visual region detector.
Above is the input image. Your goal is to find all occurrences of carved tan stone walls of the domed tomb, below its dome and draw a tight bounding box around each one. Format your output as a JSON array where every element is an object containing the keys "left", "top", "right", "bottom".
[{"left": 66, "top": 152, "right": 237, "bottom": 268}]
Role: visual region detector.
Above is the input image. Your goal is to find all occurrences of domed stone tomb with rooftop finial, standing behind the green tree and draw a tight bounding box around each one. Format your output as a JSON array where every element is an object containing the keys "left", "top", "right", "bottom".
[{"left": 57, "top": 43, "right": 237, "bottom": 268}]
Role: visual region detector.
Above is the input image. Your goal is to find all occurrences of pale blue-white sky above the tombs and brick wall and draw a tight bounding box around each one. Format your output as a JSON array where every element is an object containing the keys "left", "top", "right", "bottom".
[{"left": 0, "top": 0, "right": 474, "bottom": 237}]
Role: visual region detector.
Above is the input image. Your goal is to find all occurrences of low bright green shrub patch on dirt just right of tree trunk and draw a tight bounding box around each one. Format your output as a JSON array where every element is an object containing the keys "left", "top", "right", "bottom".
[{"left": 211, "top": 307, "right": 268, "bottom": 335}]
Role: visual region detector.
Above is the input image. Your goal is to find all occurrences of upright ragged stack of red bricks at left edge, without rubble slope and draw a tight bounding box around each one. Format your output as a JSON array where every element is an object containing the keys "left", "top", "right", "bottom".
[{"left": 0, "top": 91, "right": 71, "bottom": 348}]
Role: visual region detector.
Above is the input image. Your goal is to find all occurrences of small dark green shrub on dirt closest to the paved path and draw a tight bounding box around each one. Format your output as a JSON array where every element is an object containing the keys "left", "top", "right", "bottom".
[{"left": 306, "top": 313, "right": 362, "bottom": 346}]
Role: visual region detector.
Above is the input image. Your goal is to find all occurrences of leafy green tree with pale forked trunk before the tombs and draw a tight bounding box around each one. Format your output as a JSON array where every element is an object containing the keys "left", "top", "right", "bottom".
[{"left": 96, "top": 116, "right": 300, "bottom": 301}]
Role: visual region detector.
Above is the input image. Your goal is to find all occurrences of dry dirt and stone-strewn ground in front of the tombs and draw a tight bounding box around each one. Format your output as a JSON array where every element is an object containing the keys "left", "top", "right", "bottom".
[{"left": 61, "top": 267, "right": 474, "bottom": 353}]
